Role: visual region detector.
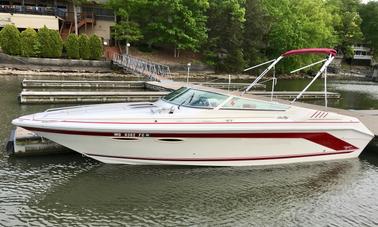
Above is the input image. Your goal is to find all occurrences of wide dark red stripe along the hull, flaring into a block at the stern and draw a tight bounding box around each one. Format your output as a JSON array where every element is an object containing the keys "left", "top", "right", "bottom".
[{"left": 25, "top": 127, "right": 358, "bottom": 151}]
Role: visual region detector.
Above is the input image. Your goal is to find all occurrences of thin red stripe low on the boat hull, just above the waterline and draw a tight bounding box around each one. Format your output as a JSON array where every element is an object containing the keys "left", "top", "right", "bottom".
[{"left": 85, "top": 151, "right": 353, "bottom": 162}]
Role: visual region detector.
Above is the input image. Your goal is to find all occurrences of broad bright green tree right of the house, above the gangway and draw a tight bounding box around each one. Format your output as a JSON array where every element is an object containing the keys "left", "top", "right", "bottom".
[{"left": 110, "top": 0, "right": 209, "bottom": 56}]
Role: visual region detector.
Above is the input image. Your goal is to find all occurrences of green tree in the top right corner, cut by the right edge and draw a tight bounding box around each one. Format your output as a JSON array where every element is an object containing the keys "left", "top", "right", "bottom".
[{"left": 359, "top": 2, "right": 378, "bottom": 57}]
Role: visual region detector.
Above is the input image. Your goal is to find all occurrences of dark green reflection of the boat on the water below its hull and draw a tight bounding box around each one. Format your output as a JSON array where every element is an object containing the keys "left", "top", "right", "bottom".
[{"left": 15, "top": 159, "right": 376, "bottom": 225}]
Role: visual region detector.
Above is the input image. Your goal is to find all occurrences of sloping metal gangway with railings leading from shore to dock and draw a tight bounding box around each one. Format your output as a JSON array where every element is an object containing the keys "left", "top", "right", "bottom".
[{"left": 113, "top": 54, "right": 171, "bottom": 81}]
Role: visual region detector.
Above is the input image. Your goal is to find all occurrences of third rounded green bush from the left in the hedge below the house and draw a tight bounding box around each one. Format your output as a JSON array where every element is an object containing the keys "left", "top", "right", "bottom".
[{"left": 38, "top": 26, "right": 63, "bottom": 58}]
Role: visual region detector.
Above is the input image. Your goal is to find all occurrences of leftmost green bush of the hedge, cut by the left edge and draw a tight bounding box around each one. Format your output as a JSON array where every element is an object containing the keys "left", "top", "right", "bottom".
[{"left": 0, "top": 24, "right": 21, "bottom": 55}]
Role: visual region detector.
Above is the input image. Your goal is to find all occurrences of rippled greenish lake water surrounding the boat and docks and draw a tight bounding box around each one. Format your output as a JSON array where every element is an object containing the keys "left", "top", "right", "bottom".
[{"left": 0, "top": 77, "right": 378, "bottom": 226}]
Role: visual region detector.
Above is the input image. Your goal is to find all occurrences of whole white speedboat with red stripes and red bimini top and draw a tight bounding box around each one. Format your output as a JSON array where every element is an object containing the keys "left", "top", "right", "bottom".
[{"left": 12, "top": 49, "right": 374, "bottom": 166}]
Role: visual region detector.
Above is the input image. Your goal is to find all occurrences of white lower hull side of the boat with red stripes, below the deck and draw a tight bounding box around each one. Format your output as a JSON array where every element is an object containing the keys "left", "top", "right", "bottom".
[{"left": 28, "top": 128, "right": 371, "bottom": 166}]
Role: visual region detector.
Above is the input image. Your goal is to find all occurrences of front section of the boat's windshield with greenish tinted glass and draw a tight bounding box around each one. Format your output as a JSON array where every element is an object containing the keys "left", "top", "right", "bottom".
[{"left": 163, "top": 87, "right": 229, "bottom": 109}]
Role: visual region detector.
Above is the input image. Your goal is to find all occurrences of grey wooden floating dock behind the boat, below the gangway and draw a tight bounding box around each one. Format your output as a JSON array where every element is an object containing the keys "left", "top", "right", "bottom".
[{"left": 19, "top": 80, "right": 340, "bottom": 104}]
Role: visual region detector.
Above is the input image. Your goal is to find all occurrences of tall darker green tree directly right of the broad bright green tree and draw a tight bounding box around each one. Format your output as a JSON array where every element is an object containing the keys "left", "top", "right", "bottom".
[{"left": 204, "top": 0, "right": 245, "bottom": 72}]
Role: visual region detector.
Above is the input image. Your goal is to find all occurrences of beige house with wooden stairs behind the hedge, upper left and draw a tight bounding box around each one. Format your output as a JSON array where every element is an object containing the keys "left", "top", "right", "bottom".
[{"left": 0, "top": 0, "right": 116, "bottom": 45}]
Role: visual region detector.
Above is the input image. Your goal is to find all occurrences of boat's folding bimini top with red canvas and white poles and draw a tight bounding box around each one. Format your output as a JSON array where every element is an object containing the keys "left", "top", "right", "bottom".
[{"left": 241, "top": 48, "right": 337, "bottom": 107}]
